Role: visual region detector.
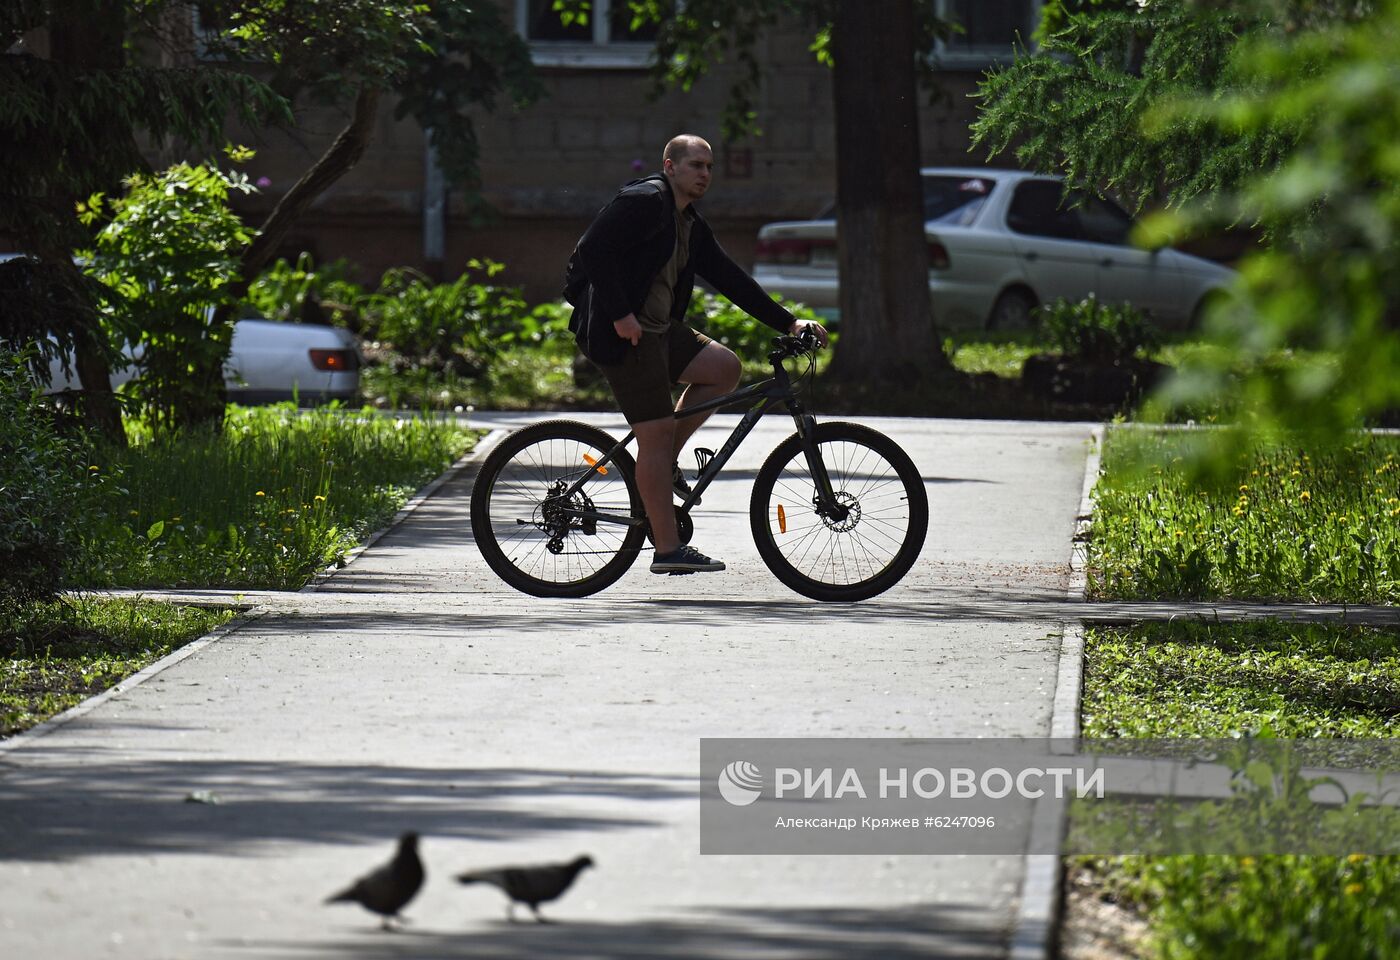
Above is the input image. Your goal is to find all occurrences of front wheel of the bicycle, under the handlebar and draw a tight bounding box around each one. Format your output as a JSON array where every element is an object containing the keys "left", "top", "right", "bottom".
[{"left": 749, "top": 421, "right": 928, "bottom": 602}]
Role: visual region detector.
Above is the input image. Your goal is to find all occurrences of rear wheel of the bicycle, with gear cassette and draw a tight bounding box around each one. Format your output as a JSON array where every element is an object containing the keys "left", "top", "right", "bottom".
[{"left": 472, "top": 420, "right": 645, "bottom": 598}]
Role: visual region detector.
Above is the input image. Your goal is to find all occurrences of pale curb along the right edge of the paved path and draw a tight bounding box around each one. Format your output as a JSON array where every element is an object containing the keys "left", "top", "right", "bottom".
[{"left": 1007, "top": 424, "right": 1103, "bottom": 960}]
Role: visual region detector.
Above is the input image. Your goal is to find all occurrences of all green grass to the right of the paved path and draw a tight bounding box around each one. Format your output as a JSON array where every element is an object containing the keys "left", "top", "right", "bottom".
[{"left": 1072, "top": 431, "right": 1400, "bottom": 960}]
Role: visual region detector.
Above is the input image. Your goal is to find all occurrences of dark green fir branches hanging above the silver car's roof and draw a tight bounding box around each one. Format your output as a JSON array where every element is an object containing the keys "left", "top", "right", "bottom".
[{"left": 972, "top": 0, "right": 1298, "bottom": 210}]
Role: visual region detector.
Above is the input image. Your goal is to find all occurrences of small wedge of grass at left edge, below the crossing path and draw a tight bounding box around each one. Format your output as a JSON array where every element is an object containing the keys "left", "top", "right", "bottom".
[{"left": 0, "top": 598, "right": 234, "bottom": 736}]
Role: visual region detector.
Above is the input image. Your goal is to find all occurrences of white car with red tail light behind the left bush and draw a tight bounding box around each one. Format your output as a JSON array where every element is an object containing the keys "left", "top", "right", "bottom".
[{"left": 49, "top": 318, "right": 360, "bottom": 404}]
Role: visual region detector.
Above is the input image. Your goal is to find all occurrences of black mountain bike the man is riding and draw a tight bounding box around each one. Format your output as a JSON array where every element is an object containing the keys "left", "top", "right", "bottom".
[{"left": 472, "top": 330, "right": 928, "bottom": 602}]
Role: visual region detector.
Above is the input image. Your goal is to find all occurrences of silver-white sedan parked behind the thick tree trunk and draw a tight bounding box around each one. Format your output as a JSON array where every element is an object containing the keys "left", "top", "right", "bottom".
[{"left": 753, "top": 168, "right": 1235, "bottom": 329}]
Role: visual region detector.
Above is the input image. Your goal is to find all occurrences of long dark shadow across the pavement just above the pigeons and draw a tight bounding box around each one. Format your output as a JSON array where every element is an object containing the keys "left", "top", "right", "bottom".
[{"left": 0, "top": 761, "right": 683, "bottom": 862}]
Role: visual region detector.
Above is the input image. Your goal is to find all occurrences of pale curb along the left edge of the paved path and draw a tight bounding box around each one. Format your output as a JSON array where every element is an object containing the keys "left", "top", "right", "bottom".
[{"left": 0, "top": 430, "right": 508, "bottom": 756}]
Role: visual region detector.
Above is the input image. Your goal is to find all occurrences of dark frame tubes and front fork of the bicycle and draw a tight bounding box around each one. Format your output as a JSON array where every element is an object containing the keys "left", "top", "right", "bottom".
[{"left": 561, "top": 345, "right": 846, "bottom": 526}]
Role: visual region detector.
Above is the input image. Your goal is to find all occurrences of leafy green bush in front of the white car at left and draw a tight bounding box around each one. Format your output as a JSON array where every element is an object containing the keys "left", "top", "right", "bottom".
[{"left": 83, "top": 164, "right": 253, "bottom": 431}]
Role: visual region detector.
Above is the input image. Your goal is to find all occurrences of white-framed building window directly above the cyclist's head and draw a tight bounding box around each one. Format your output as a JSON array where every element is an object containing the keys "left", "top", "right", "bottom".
[{"left": 515, "top": 0, "right": 657, "bottom": 67}]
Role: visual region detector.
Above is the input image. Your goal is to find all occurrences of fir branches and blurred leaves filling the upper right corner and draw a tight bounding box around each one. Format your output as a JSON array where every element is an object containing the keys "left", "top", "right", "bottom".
[{"left": 974, "top": 0, "right": 1400, "bottom": 450}]
